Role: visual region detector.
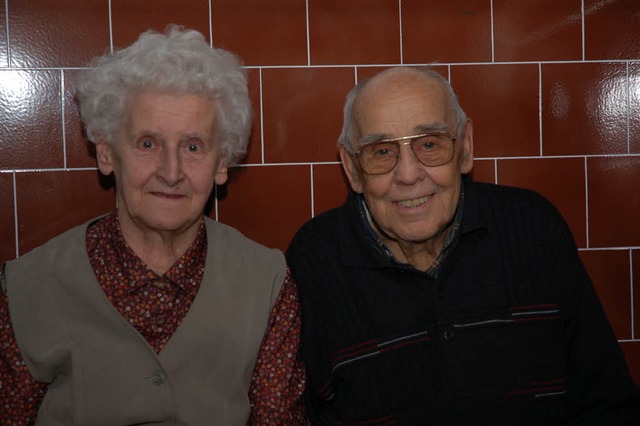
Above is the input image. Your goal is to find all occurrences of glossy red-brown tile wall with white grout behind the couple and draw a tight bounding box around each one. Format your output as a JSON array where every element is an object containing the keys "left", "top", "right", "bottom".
[{"left": 0, "top": 0, "right": 640, "bottom": 382}]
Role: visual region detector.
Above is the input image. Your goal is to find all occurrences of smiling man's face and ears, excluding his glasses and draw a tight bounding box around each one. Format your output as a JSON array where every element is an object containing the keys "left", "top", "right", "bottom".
[{"left": 341, "top": 71, "right": 473, "bottom": 247}]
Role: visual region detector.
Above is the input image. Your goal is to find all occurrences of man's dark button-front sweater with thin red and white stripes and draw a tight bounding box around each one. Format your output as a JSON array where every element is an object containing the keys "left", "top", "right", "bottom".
[{"left": 287, "top": 179, "right": 640, "bottom": 426}]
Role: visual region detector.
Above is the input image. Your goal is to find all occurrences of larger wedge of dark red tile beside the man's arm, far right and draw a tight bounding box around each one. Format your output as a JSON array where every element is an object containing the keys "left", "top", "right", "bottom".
[{"left": 580, "top": 250, "right": 631, "bottom": 339}]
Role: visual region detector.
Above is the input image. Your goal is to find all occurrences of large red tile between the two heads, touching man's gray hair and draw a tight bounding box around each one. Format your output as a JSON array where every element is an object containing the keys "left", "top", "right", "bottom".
[{"left": 262, "top": 68, "right": 354, "bottom": 163}]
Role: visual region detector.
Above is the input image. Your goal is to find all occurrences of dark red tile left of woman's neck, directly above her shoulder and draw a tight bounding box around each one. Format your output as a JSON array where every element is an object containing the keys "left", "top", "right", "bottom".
[{"left": 16, "top": 170, "right": 115, "bottom": 255}]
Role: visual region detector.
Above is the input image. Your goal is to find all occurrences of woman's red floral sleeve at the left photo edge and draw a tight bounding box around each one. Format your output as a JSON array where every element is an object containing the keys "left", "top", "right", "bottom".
[{"left": 0, "top": 272, "right": 47, "bottom": 426}]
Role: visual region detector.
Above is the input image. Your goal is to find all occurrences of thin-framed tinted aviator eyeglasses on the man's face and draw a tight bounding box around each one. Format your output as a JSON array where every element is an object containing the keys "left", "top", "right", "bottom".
[{"left": 355, "top": 132, "right": 456, "bottom": 175}]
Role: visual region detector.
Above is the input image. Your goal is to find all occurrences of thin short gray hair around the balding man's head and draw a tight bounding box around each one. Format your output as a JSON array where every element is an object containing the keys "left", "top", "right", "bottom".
[{"left": 338, "top": 67, "right": 467, "bottom": 154}]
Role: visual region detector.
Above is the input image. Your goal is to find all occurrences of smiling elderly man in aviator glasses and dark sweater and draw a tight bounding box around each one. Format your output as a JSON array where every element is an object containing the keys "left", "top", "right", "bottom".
[{"left": 287, "top": 68, "right": 640, "bottom": 425}]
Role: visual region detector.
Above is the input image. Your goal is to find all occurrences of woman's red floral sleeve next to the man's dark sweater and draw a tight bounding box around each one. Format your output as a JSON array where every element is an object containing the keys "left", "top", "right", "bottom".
[{"left": 248, "top": 270, "right": 309, "bottom": 426}]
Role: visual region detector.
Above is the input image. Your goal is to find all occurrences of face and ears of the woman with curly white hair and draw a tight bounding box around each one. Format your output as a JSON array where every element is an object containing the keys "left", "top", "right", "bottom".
[{"left": 97, "top": 92, "right": 227, "bottom": 241}]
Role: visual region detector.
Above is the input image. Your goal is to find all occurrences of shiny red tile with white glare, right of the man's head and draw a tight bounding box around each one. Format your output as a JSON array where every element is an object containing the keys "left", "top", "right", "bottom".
[{"left": 542, "top": 63, "right": 628, "bottom": 155}]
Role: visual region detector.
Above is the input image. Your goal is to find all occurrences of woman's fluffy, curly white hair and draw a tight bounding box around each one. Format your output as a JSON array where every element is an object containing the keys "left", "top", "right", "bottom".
[{"left": 77, "top": 25, "right": 252, "bottom": 165}]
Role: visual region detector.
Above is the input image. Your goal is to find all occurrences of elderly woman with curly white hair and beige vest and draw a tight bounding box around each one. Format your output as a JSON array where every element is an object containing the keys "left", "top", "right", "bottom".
[{"left": 0, "top": 26, "right": 304, "bottom": 425}]
